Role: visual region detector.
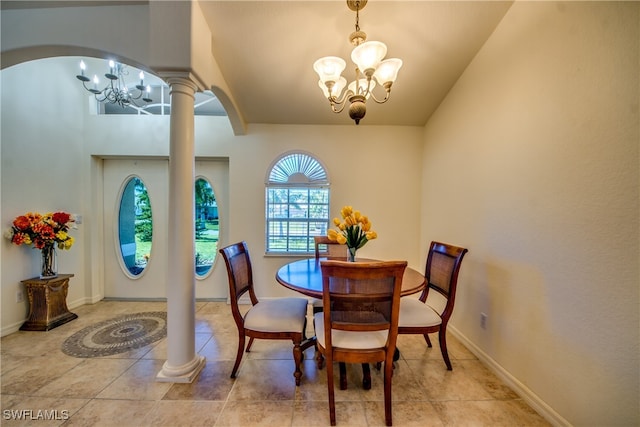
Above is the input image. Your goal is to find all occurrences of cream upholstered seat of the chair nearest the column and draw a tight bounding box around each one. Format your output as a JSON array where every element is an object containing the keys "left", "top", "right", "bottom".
[{"left": 244, "top": 298, "right": 307, "bottom": 332}]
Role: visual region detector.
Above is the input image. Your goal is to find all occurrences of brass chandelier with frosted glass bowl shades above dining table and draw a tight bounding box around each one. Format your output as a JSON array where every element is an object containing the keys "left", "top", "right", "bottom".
[{"left": 313, "top": 0, "right": 402, "bottom": 125}]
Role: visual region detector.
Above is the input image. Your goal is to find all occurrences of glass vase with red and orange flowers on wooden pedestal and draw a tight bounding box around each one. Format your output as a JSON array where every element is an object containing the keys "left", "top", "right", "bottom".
[{"left": 7, "top": 212, "right": 75, "bottom": 279}]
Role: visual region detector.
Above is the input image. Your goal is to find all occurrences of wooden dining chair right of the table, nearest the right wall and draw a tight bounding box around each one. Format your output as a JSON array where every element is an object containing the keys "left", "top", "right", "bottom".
[{"left": 398, "top": 242, "right": 468, "bottom": 371}]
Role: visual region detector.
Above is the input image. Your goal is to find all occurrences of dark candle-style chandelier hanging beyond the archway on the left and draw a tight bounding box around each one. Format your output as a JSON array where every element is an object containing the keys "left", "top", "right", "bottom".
[{"left": 76, "top": 61, "right": 153, "bottom": 108}]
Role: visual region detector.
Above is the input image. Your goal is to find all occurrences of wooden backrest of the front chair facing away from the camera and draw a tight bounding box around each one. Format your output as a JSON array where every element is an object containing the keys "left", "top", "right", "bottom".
[{"left": 320, "top": 260, "right": 407, "bottom": 349}]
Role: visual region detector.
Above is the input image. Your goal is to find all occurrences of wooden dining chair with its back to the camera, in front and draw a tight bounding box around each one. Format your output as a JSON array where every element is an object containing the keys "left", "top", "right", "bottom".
[{"left": 314, "top": 260, "right": 407, "bottom": 426}]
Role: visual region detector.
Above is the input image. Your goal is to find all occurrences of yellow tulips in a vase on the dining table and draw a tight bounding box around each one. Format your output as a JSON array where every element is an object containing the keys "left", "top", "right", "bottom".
[{"left": 327, "top": 206, "right": 378, "bottom": 262}]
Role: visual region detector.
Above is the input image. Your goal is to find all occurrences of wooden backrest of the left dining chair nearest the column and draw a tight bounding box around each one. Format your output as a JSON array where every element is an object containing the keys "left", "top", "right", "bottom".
[{"left": 219, "top": 242, "right": 258, "bottom": 315}]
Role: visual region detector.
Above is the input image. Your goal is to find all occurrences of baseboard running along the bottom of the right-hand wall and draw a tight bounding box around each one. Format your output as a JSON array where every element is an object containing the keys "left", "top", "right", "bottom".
[{"left": 447, "top": 325, "right": 571, "bottom": 427}]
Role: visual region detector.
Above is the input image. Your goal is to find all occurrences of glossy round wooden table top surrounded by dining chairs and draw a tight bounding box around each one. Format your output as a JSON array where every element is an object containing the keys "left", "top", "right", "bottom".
[{"left": 276, "top": 258, "right": 425, "bottom": 299}]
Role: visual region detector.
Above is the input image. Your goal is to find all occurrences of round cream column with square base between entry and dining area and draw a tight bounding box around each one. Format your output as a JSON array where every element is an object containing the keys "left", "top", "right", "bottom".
[{"left": 156, "top": 73, "right": 205, "bottom": 383}]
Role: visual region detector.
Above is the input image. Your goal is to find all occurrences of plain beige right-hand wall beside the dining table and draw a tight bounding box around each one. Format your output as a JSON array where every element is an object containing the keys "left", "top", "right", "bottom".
[{"left": 422, "top": 2, "right": 640, "bottom": 426}]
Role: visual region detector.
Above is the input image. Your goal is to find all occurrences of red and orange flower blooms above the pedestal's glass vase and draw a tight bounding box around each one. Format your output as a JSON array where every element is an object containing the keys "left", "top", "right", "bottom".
[{"left": 7, "top": 212, "right": 75, "bottom": 249}]
